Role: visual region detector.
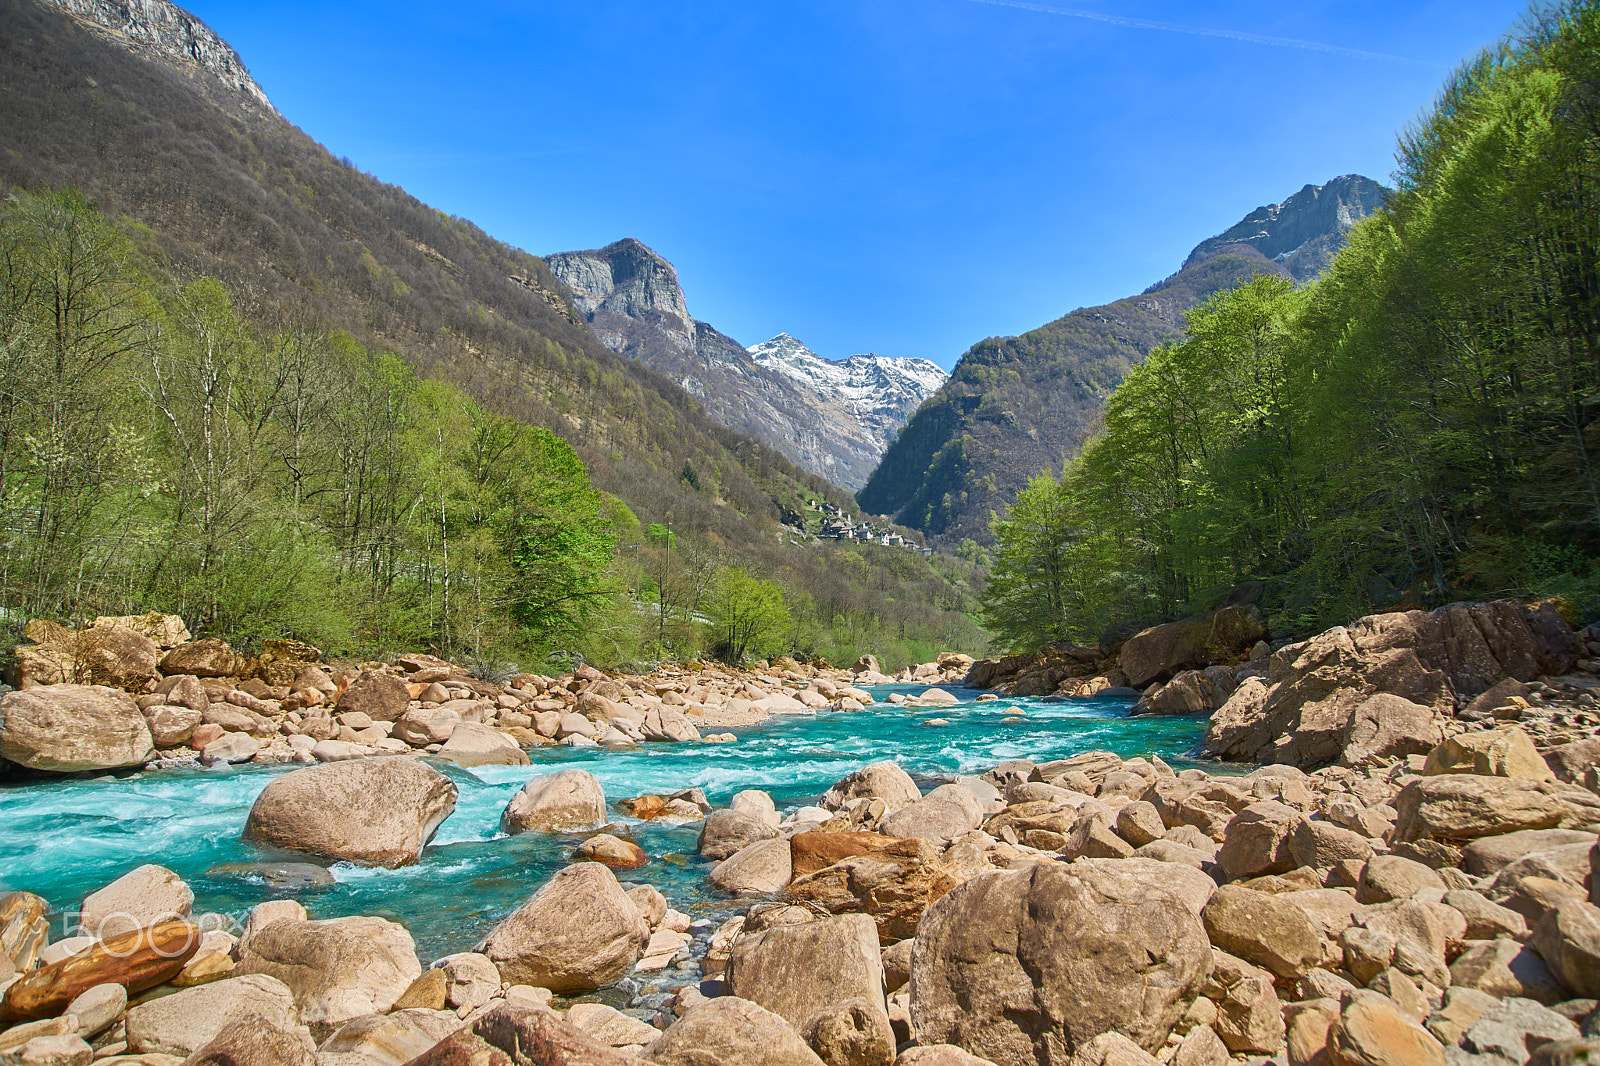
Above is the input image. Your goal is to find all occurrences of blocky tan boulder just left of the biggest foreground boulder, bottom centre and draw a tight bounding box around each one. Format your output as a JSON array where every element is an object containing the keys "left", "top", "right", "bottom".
[{"left": 726, "top": 914, "right": 888, "bottom": 1028}]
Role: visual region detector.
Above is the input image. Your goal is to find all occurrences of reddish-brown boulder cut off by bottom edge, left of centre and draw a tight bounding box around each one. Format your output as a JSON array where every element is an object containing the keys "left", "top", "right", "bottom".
[{"left": 400, "top": 1004, "right": 648, "bottom": 1066}]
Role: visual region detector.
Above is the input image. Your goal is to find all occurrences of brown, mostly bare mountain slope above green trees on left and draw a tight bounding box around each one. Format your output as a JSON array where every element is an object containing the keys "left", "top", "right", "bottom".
[{"left": 0, "top": 0, "right": 971, "bottom": 653}]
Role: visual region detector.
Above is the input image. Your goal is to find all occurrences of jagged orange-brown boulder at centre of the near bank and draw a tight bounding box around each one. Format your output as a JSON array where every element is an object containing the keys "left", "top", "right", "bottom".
[{"left": 786, "top": 834, "right": 957, "bottom": 943}]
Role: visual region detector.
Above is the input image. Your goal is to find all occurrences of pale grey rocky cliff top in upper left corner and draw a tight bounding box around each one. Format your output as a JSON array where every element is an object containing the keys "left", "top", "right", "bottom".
[{"left": 43, "top": 0, "right": 277, "bottom": 114}]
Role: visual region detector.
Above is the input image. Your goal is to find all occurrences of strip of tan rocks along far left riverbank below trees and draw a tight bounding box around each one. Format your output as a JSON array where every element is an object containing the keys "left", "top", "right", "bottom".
[{"left": 0, "top": 615, "right": 971, "bottom": 773}]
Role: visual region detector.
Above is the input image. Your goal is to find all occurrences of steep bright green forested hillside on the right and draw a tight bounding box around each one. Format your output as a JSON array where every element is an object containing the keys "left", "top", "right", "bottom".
[{"left": 987, "top": 3, "right": 1600, "bottom": 647}]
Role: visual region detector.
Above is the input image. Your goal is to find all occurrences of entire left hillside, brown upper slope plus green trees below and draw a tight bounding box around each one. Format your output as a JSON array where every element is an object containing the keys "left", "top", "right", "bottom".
[{"left": 0, "top": 0, "right": 981, "bottom": 659}]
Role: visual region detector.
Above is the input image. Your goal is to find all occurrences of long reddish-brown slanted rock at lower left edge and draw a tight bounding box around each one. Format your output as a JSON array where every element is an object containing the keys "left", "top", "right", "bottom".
[{"left": 0, "top": 922, "right": 202, "bottom": 1021}]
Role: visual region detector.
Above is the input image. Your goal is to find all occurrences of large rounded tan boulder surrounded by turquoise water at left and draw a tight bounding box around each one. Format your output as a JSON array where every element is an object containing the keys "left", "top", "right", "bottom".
[{"left": 245, "top": 757, "right": 456, "bottom": 866}]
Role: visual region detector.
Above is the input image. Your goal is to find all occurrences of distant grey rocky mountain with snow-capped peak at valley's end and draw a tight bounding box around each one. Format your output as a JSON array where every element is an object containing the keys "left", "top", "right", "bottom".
[{"left": 546, "top": 238, "right": 946, "bottom": 490}]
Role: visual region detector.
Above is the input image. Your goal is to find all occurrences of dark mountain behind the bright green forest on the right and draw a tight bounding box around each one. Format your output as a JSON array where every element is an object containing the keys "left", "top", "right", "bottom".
[{"left": 856, "top": 174, "right": 1389, "bottom": 544}]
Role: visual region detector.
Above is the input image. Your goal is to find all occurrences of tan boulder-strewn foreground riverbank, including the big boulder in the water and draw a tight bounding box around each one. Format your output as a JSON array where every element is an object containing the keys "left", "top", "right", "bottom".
[{"left": 15, "top": 723, "right": 1600, "bottom": 1066}]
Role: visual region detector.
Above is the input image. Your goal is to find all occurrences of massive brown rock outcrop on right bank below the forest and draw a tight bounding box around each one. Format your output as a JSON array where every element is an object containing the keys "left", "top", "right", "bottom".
[{"left": 1205, "top": 602, "right": 1582, "bottom": 767}]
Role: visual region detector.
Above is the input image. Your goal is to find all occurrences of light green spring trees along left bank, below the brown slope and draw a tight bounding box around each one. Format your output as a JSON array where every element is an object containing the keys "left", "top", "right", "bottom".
[{"left": 0, "top": 190, "right": 981, "bottom": 666}]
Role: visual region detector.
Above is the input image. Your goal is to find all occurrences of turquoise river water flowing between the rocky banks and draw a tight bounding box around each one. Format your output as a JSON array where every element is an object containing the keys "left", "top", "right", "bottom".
[{"left": 0, "top": 685, "right": 1205, "bottom": 959}]
